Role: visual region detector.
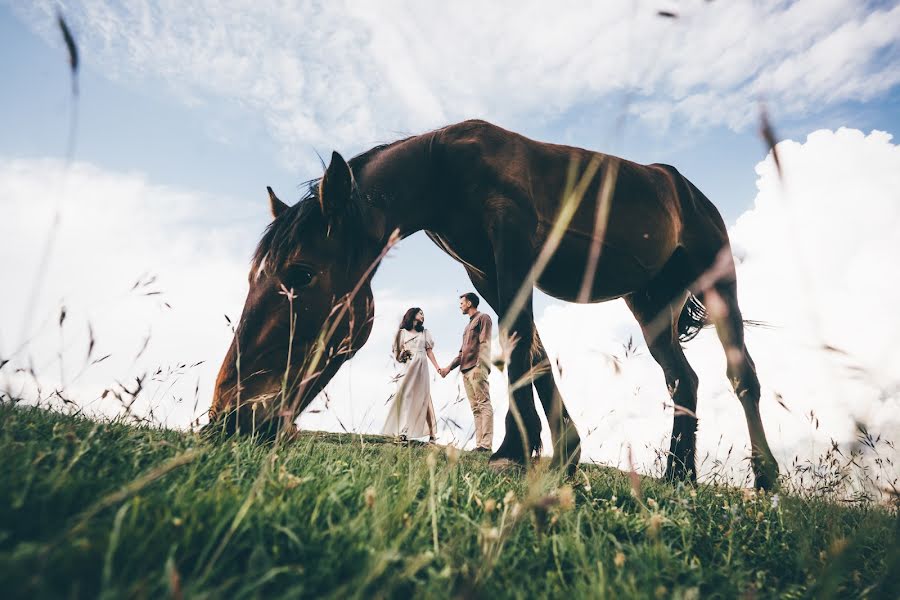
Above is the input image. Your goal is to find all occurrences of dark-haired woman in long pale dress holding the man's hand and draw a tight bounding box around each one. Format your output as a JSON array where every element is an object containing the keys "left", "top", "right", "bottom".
[{"left": 384, "top": 307, "right": 440, "bottom": 442}]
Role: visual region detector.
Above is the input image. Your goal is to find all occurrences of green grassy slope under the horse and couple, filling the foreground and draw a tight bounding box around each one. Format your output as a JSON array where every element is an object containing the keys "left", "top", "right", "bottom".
[{"left": 0, "top": 403, "right": 900, "bottom": 598}]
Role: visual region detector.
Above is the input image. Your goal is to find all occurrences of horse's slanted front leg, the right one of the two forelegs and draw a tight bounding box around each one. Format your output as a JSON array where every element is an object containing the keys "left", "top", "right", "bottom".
[{"left": 532, "top": 329, "right": 581, "bottom": 472}]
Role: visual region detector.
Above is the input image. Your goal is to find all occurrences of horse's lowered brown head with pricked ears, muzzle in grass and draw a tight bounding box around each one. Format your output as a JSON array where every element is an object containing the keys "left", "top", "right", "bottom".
[{"left": 210, "top": 152, "right": 384, "bottom": 432}]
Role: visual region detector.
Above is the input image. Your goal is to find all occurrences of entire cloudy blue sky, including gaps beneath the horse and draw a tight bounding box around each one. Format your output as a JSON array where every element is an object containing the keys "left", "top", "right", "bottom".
[{"left": 0, "top": 0, "right": 900, "bottom": 488}]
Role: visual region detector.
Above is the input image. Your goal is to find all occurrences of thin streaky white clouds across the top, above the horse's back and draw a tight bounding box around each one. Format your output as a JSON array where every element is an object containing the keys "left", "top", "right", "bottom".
[{"left": 14, "top": 0, "right": 900, "bottom": 164}]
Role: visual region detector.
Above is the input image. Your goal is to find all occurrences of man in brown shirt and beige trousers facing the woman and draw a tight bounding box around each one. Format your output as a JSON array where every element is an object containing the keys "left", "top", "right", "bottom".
[{"left": 439, "top": 292, "right": 494, "bottom": 452}]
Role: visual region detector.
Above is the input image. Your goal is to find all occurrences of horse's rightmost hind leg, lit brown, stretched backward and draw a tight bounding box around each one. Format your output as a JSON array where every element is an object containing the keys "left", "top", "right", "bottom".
[{"left": 704, "top": 279, "right": 778, "bottom": 490}]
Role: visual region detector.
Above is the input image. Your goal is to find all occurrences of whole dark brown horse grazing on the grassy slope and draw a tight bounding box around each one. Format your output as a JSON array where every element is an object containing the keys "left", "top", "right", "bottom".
[{"left": 210, "top": 120, "right": 778, "bottom": 488}]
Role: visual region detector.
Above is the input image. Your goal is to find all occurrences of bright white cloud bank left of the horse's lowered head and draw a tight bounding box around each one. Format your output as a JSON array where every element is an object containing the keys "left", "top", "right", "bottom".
[{"left": 0, "top": 160, "right": 253, "bottom": 426}]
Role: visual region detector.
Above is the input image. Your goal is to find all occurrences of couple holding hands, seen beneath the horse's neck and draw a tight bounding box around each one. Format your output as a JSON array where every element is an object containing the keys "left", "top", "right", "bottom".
[{"left": 384, "top": 292, "right": 494, "bottom": 452}]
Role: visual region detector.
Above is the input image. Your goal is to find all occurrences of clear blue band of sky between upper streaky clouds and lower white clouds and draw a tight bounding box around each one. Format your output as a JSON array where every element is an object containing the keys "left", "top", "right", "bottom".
[{"left": 7, "top": 3, "right": 900, "bottom": 222}]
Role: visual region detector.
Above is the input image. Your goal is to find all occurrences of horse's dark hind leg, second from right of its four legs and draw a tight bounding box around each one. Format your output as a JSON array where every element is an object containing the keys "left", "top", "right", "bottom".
[{"left": 625, "top": 286, "right": 698, "bottom": 481}]
